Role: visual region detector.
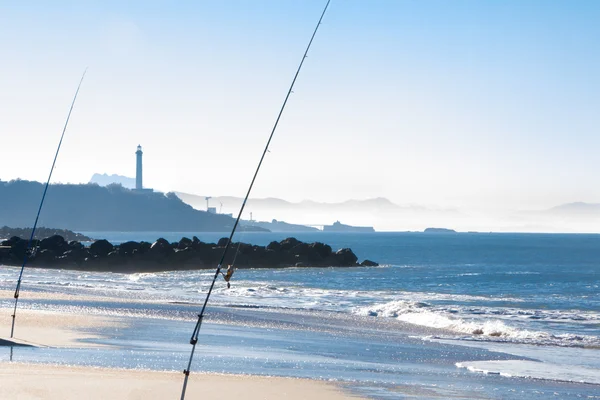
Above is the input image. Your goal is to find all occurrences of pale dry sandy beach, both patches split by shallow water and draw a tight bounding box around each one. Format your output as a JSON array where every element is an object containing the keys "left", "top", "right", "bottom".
[{"left": 0, "top": 308, "right": 358, "bottom": 400}]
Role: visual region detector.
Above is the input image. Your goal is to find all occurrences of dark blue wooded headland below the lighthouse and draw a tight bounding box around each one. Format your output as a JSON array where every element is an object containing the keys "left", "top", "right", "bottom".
[{"left": 0, "top": 180, "right": 265, "bottom": 232}]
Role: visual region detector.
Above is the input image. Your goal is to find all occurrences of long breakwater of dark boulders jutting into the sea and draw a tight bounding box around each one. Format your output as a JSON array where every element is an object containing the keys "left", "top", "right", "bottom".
[{"left": 0, "top": 235, "right": 378, "bottom": 273}]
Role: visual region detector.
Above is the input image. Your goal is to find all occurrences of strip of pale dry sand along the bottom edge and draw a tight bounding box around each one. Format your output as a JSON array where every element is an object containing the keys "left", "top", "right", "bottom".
[{"left": 0, "top": 363, "right": 358, "bottom": 400}]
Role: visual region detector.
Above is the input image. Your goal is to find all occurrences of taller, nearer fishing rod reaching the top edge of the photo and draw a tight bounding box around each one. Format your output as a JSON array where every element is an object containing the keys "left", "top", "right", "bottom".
[{"left": 181, "top": 0, "right": 331, "bottom": 400}]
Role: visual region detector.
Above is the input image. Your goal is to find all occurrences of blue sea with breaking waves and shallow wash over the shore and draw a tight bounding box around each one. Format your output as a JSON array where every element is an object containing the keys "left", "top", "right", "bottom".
[{"left": 0, "top": 232, "right": 600, "bottom": 399}]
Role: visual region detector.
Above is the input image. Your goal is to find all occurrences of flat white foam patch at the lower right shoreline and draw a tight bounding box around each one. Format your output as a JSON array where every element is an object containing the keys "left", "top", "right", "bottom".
[{"left": 456, "top": 360, "right": 600, "bottom": 385}]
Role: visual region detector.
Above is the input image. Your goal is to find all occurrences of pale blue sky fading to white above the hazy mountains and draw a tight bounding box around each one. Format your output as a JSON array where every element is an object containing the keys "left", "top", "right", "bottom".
[{"left": 0, "top": 0, "right": 600, "bottom": 209}]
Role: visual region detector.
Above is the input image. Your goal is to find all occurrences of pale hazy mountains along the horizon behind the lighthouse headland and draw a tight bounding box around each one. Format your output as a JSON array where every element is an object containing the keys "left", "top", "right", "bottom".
[{"left": 3, "top": 174, "right": 600, "bottom": 233}]
